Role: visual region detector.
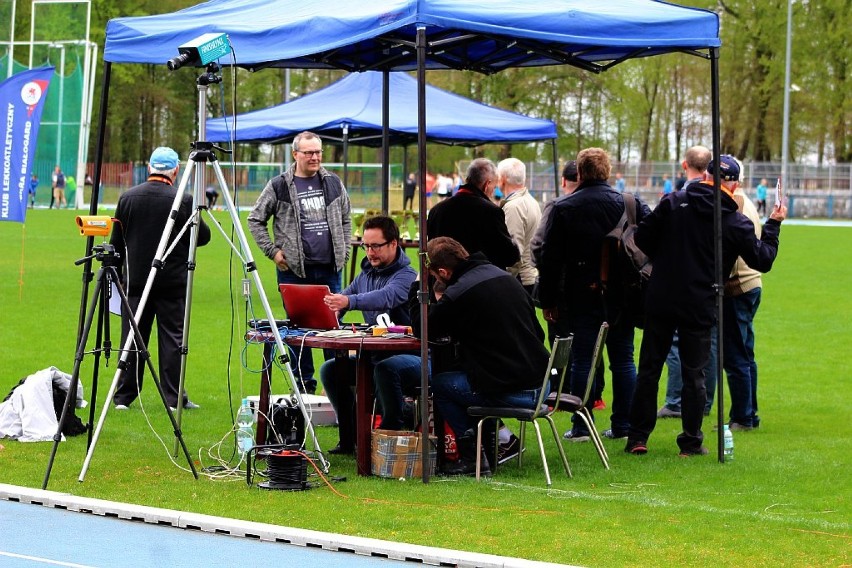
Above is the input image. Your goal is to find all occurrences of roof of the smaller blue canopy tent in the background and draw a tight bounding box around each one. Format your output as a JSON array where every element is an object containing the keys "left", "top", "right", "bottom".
[{"left": 207, "top": 71, "right": 557, "bottom": 146}]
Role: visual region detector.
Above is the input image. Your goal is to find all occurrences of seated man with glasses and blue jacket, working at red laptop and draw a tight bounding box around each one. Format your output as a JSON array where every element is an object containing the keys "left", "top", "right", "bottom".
[{"left": 320, "top": 216, "right": 420, "bottom": 454}]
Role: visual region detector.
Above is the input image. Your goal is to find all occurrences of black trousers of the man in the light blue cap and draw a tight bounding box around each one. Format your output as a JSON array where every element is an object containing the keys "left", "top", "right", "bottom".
[{"left": 113, "top": 290, "right": 187, "bottom": 408}]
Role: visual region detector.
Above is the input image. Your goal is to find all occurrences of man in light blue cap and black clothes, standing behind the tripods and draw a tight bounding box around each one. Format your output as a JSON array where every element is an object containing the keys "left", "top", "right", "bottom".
[{"left": 110, "top": 146, "right": 210, "bottom": 410}]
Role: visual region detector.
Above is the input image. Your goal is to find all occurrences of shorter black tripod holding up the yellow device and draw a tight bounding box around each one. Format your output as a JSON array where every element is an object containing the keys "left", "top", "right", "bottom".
[{"left": 42, "top": 244, "right": 198, "bottom": 489}]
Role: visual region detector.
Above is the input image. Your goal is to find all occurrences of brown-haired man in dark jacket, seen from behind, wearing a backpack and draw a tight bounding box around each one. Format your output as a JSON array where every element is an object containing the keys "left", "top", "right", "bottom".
[{"left": 538, "top": 148, "right": 649, "bottom": 442}]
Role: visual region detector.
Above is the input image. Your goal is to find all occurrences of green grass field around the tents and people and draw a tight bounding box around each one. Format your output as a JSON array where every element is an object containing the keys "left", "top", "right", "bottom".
[{"left": 0, "top": 210, "right": 852, "bottom": 567}]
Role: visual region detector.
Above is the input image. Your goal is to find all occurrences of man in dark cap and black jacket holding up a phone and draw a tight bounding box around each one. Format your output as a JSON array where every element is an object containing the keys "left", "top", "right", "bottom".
[{"left": 625, "top": 155, "right": 787, "bottom": 457}]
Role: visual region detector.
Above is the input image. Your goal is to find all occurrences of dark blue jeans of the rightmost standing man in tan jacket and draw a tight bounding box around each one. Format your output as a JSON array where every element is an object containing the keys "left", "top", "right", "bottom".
[{"left": 722, "top": 288, "right": 761, "bottom": 426}]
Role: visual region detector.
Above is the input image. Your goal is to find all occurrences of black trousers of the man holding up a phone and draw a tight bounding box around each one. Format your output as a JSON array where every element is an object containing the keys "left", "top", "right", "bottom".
[{"left": 628, "top": 318, "right": 711, "bottom": 452}]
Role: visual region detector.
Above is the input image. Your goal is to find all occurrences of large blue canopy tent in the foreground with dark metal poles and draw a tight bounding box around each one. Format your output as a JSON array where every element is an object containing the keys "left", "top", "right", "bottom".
[{"left": 91, "top": 0, "right": 723, "bottom": 481}]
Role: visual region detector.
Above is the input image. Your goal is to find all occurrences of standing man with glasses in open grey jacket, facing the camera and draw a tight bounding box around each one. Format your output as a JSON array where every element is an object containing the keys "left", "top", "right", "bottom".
[{"left": 248, "top": 131, "right": 352, "bottom": 394}]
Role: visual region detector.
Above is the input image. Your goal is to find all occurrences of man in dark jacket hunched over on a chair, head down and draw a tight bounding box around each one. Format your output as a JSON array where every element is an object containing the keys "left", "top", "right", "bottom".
[{"left": 409, "top": 235, "right": 549, "bottom": 475}]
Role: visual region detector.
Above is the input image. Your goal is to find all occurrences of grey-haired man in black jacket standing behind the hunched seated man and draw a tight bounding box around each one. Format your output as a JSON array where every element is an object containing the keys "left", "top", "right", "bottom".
[{"left": 426, "top": 158, "right": 521, "bottom": 269}]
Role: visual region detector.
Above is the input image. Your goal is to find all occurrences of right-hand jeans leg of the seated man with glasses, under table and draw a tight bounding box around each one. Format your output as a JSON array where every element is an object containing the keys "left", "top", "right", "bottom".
[{"left": 373, "top": 354, "right": 430, "bottom": 430}]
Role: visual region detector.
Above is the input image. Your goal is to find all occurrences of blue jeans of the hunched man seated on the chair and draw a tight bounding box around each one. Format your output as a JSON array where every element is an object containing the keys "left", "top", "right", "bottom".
[{"left": 432, "top": 371, "right": 541, "bottom": 438}]
